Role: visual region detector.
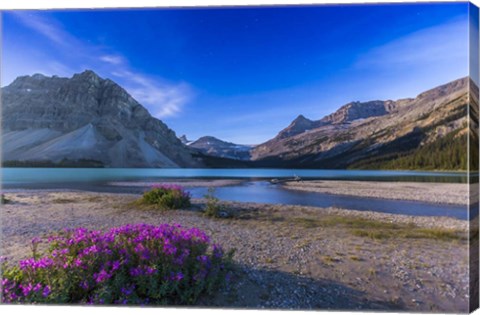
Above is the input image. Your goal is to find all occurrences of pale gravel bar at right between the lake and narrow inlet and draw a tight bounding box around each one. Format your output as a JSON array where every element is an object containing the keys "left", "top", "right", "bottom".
[{"left": 283, "top": 180, "right": 469, "bottom": 205}]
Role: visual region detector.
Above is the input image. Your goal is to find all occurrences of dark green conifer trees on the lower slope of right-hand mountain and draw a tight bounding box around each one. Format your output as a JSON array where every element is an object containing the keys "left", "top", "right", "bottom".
[{"left": 352, "top": 130, "right": 468, "bottom": 171}]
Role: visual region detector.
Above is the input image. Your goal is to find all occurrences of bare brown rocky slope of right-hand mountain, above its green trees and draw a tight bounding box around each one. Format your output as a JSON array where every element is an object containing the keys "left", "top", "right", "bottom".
[{"left": 252, "top": 77, "right": 469, "bottom": 169}]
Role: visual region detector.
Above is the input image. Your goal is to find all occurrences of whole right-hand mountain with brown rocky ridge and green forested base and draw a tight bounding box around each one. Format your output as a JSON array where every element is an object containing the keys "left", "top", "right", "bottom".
[{"left": 251, "top": 78, "right": 470, "bottom": 169}]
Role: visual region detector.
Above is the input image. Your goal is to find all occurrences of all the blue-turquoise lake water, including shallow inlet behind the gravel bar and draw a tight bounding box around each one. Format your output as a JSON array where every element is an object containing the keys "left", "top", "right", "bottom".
[{"left": 2, "top": 168, "right": 472, "bottom": 220}]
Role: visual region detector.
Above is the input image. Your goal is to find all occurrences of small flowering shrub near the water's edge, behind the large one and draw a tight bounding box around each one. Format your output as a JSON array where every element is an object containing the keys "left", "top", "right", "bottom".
[{"left": 142, "top": 185, "right": 191, "bottom": 209}]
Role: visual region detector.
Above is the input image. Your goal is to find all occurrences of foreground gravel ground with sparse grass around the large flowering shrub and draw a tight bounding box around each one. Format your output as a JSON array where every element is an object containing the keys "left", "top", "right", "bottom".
[{"left": 1, "top": 190, "right": 469, "bottom": 313}]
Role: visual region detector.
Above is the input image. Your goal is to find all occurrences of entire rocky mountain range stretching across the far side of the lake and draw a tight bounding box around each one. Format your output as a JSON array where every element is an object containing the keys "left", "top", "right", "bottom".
[{"left": 2, "top": 71, "right": 478, "bottom": 169}]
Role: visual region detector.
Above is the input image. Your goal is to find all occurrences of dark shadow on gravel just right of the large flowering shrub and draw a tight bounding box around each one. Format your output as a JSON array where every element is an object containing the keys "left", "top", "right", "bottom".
[{"left": 199, "top": 266, "right": 405, "bottom": 311}]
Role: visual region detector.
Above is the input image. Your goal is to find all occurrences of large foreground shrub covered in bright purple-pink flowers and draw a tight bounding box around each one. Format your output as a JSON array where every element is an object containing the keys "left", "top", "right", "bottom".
[{"left": 1, "top": 224, "right": 233, "bottom": 305}]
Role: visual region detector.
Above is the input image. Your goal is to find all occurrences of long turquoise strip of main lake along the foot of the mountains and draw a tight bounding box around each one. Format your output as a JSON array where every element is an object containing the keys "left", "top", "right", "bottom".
[{"left": 2, "top": 168, "right": 467, "bottom": 186}]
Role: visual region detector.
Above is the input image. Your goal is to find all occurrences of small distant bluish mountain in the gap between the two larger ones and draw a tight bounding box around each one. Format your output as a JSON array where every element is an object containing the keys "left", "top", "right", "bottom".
[{"left": 189, "top": 136, "right": 252, "bottom": 161}]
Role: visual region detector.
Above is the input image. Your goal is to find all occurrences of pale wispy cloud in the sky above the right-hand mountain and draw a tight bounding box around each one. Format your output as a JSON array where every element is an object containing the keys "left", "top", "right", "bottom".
[{"left": 343, "top": 17, "right": 468, "bottom": 101}]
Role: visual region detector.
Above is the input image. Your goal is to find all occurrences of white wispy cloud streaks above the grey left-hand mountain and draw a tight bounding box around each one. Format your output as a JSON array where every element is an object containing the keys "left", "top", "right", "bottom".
[{"left": 6, "top": 11, "right": 193, "bottom": 118}]
